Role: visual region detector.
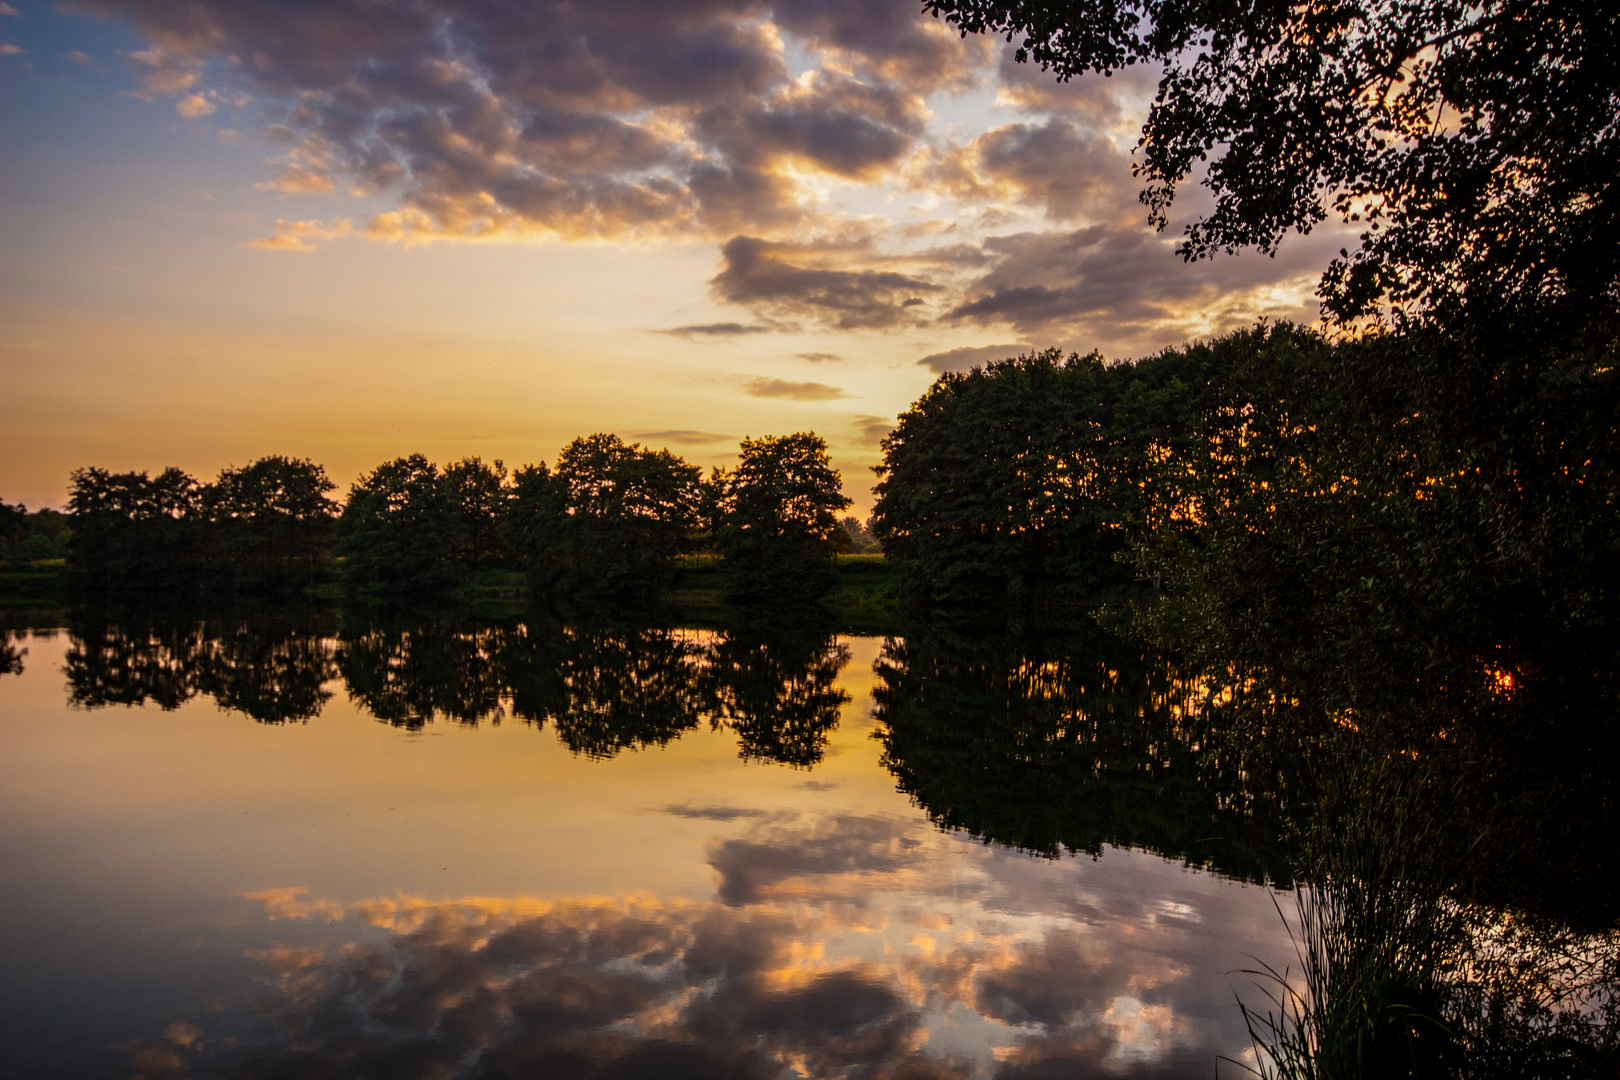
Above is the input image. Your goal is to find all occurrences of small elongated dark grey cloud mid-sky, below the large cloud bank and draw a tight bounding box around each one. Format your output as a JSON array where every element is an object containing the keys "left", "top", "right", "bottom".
[{"left": 710, "top": 236, "right": 940, "bottom": 330}]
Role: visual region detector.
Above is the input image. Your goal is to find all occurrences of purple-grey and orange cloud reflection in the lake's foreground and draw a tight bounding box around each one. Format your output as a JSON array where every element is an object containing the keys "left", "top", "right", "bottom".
[{"left": 126, "top": 814, "right": 1270, "bottom": 1078}]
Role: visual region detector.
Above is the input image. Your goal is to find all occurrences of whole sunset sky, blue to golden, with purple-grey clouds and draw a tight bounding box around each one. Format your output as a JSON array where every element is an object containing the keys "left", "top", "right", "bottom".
[{"left": 0, "top": 0, "right": 1346, "bottom": 513}]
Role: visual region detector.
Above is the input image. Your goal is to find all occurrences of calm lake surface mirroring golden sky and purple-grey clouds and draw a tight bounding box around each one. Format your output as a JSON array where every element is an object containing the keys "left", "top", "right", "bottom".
[{"left": 0, "top": 628, "right": 1291, "bottom": 1078}]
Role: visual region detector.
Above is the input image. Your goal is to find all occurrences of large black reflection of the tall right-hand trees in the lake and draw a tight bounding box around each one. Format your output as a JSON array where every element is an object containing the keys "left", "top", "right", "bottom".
[{"left": 876, "top": 627, "right": 1290, "bottom": 884}]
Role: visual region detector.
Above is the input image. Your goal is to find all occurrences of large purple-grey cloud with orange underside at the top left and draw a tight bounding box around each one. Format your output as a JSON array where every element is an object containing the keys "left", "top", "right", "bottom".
[{"left": 86, "top": 0, "right": 990, "bottom": 238}]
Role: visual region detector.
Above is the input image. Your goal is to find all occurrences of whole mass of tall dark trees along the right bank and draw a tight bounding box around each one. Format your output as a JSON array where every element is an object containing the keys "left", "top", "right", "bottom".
[{"left": 873, "top": 324, "right": 1620, "bottom": 761}]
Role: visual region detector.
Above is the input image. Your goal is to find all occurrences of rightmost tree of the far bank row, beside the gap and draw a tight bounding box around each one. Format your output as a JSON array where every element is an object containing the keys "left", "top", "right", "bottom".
[{"left": 713, "top": 431, "right": 849, "bottom": 599}]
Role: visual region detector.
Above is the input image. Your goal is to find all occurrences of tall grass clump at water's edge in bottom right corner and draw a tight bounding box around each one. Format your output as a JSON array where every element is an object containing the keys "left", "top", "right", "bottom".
[{"left": 1231, "top": 756, "right": 1620, "bottom": 1080}]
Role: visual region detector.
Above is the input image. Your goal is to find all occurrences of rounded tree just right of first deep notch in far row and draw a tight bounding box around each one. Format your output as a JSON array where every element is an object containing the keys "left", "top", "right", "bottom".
[{"left": 337, "top": 453, "right": 460, "bottom": 594}]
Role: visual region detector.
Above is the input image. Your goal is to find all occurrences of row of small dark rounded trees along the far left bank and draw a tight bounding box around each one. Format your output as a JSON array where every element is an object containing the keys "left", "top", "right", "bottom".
[{"left": 57, "top": 432, "right": 873, "bottom": 599}]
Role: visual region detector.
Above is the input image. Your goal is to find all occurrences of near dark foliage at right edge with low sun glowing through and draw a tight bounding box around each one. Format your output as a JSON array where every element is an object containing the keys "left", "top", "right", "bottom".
[{"left": 1140, "top": 330, "right": 1620, "bottom": 757}]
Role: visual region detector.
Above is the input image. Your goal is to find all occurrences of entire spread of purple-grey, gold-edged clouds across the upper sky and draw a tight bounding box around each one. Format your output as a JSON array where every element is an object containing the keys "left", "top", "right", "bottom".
[{"left": 81, "top": 0, "right": 1341, "bottom": 356}]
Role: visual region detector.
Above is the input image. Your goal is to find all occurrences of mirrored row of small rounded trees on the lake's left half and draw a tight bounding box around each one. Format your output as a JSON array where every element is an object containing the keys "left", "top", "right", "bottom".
[{"left": 57, "top": 610, "right": 849, "bottom": 767}]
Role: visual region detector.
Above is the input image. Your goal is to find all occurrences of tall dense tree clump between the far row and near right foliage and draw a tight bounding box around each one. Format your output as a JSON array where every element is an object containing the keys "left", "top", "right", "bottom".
[{"left": 873, "top": 350, "right": 1218, "bottom": 604}]
